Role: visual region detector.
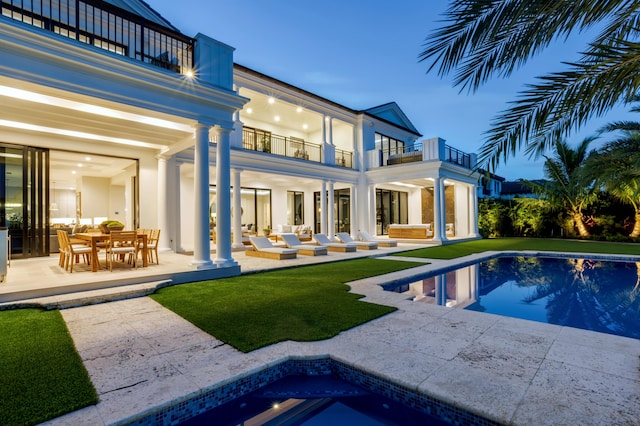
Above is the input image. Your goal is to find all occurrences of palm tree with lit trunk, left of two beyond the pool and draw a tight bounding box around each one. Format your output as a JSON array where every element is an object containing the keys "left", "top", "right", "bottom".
[{"left": 527, "top": 137, "right": 596, "bottom": 237}]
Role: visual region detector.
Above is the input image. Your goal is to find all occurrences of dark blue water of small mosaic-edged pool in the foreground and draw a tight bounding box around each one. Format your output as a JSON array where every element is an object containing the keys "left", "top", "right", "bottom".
[{"left": 182, "top": 375, "right": 450, "bottom": 426}]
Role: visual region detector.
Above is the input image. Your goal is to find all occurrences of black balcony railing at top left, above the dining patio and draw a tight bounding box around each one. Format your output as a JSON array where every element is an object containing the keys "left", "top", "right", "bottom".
[{"left": 2, "top": 0, "right": 195, "bottom": 74}]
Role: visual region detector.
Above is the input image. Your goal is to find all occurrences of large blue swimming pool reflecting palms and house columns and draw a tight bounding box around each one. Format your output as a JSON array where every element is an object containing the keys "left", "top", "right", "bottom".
[{"left": 383, "top": 257, "right": 640, "bottom": 339}]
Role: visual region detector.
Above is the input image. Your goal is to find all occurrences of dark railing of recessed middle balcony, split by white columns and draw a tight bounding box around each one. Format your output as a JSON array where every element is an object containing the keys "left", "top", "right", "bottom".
[{"left": 242, "top": 127, "right": 353, "bottom": 168}]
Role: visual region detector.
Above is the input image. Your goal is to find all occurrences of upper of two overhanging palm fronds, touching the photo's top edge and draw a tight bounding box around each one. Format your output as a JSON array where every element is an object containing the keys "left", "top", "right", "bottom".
[{"left": 418, "top": 0, "right": 636, "bottom": 90}]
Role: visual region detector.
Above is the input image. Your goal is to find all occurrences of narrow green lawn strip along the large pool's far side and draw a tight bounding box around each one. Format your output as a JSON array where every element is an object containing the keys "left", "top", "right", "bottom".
[{"left": 395, "top": 238, "right": 640, "bottom": 259}]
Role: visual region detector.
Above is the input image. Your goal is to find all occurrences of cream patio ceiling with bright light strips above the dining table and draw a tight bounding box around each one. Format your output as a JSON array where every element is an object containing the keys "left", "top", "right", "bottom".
[{"left": 0, "top": 77, "right": 192, "bottom": 150}]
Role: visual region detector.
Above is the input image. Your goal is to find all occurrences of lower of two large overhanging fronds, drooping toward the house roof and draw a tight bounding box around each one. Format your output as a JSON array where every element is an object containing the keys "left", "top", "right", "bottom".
[{"left": 478, "top": 40, "right": 640, "bottom": 170}]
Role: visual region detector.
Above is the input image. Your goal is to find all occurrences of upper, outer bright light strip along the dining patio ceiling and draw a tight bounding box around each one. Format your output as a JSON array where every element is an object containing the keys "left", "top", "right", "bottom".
[{"left": 0, "top": 85, "right": 193, "bottom": 133}]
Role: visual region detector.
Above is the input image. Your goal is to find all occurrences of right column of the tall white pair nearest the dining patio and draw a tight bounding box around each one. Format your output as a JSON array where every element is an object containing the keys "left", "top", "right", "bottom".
[{"left": 216, "top": 126, "right": 238, "bottom": 268}]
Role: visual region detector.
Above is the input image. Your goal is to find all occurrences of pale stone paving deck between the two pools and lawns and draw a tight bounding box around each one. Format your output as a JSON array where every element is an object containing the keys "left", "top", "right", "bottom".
[{"left": 38, "top": 251, "right": 640, "bottom": 425}]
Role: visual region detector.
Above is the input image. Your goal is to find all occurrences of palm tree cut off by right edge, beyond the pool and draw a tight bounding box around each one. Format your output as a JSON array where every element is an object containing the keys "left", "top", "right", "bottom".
[{"left": 584, "top": 128, "right": 640, "bottom": 238}]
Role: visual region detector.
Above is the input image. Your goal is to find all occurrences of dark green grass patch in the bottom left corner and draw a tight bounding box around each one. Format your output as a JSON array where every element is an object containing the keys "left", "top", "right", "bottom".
[{"left": 0, "top": 309, "right": 98, "bottom": 425}]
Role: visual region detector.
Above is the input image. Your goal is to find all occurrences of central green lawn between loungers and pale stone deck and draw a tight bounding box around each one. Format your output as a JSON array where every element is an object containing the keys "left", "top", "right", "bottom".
[{"left": 151, "top": 259, "right": 423, "bottom": 352}]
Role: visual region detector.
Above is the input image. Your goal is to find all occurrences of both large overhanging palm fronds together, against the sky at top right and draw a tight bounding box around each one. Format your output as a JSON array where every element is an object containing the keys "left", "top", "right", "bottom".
[{"left": 419, "top": 0, "right": 640, "bottom": 169}]
